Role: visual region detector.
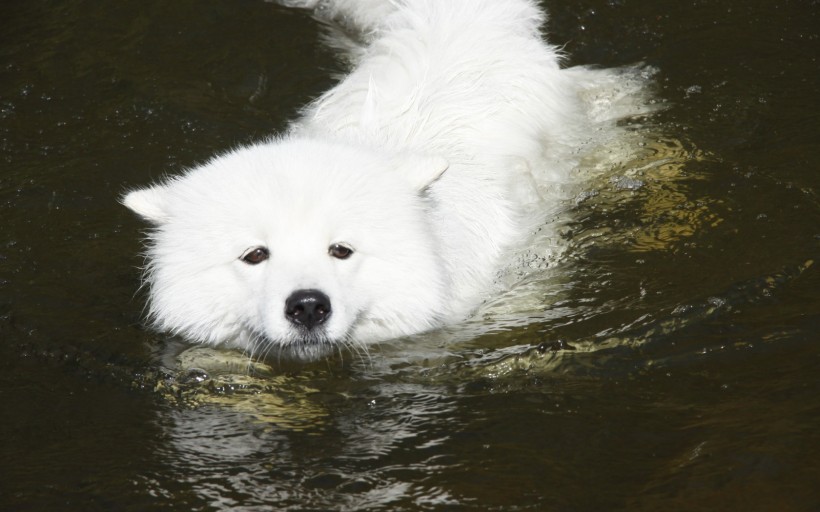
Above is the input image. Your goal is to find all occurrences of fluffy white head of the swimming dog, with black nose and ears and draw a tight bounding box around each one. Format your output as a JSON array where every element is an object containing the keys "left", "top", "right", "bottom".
[{"left": 123, "top": 139, "right": 447, "bottom": 359}]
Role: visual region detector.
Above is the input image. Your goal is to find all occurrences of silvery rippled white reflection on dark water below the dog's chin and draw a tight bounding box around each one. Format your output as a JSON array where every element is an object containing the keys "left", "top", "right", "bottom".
[{"left": 157, "top": 385, "right": 464, "bottom": 510}]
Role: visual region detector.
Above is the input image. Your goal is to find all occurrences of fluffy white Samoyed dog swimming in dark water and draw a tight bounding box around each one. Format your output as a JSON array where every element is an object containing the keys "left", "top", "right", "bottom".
[{"left": 123, "top": 0, "right": 652, "bottom": 359}]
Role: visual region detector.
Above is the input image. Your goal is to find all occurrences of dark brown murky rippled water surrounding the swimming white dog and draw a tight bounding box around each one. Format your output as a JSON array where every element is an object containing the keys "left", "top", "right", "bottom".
[{"left": 0, "top": 0, "right": 820, "bottom": 511}]
